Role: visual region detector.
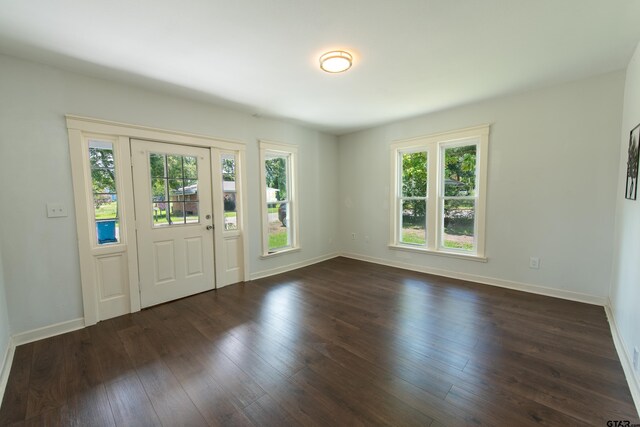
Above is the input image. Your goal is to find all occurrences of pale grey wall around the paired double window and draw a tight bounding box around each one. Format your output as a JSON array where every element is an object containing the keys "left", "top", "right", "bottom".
[{"left": 339, "top": 72, "right": 624, "bottom": 302}]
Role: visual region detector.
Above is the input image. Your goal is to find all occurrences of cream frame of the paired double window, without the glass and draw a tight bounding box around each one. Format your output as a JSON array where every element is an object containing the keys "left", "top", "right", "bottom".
[{"left": 389, "top": 125, "right": 489, "bottom": 262}]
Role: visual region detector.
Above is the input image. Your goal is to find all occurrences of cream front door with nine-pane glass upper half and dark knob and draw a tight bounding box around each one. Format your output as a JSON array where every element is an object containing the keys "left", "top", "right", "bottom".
[{"left": 131, "top": 140, "right": 215, "bottom": 307}]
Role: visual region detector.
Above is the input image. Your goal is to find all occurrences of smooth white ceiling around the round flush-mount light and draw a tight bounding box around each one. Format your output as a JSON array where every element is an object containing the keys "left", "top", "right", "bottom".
[{"left": 0, "top": 0, "right": 640, "bottom": 134}]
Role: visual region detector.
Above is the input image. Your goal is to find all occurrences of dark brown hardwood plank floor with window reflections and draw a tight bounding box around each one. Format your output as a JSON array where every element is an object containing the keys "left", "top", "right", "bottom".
[{"left": 0, "top": 258, "right": 640, "bottom": 426}]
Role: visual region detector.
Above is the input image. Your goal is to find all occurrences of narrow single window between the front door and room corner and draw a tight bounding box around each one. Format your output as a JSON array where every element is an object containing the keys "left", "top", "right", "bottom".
[{"left": 260, "top": 141, "right": 298, "bottom": 256}]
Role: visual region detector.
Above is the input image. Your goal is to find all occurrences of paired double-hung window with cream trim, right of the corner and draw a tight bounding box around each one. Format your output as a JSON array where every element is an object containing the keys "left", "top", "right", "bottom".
[{"left": 390, "top": 125, "right": 489, "bottom": 259}]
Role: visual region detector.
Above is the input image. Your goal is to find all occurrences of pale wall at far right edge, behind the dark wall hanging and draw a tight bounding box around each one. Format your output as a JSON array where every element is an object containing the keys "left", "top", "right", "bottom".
[{"left": 610, "top": 40, "right": 640, "bottom": 398}]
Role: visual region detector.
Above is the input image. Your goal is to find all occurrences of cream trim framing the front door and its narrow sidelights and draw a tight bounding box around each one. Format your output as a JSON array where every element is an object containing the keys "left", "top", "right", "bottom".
[{"left": 65, "top": 115, "right": 249, "bottom": 325}]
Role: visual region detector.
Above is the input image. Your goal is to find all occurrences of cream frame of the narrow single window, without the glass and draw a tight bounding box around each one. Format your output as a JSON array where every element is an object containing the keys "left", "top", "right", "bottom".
[{"left": 259, "top": 140, "right": 300, "bottom": 258}]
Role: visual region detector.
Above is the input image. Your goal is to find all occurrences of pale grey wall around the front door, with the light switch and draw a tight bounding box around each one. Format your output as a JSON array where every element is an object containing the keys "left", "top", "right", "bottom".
[{"left": 0, "top": 56, "right": 338, "bottom": 333}]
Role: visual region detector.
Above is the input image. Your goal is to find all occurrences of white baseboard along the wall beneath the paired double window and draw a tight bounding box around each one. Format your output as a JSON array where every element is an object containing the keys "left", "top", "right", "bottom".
[{"left": 341, "top": 253, "right": 607, "bottom": 306}]
